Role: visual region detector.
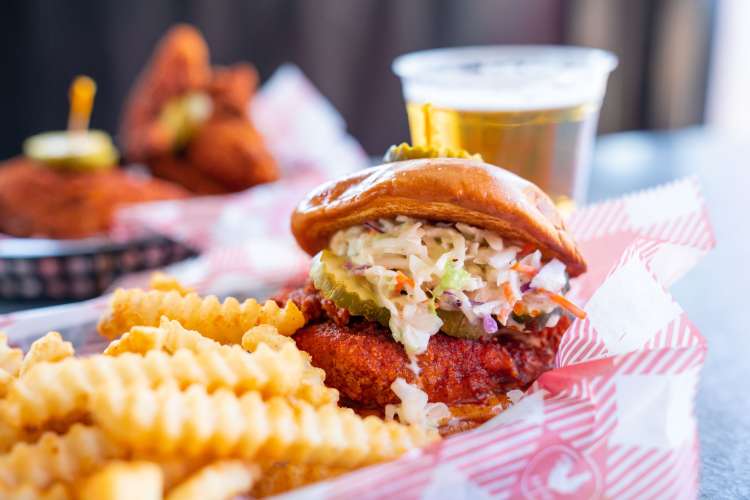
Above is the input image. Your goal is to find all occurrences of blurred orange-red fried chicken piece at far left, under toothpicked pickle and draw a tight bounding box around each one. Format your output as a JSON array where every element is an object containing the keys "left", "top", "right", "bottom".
[{"left": 0, "top": 157, "right": 188, "bottom": 239}]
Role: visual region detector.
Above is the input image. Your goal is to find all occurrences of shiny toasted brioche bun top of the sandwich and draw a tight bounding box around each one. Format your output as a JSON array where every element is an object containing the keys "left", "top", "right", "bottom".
[{"left": 292, "top": 158, "right": 586, "bottom": 276}]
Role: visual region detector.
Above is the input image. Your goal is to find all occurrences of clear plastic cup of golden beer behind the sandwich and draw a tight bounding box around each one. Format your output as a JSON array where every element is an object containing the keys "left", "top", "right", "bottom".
[{"left": 393, "top": 45, "right": 617, "bottom": 210}]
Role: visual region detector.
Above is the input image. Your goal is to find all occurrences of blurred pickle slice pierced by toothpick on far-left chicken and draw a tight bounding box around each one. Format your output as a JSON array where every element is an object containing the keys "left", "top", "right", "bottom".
[{"left": 23, "top": 130, "right": 119, "bottom": 171}]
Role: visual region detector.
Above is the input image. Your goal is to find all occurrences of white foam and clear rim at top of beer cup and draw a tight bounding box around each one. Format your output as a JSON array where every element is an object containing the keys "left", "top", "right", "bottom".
[{"left": 393, "top": 46, "right": 617, "bottom": 111}]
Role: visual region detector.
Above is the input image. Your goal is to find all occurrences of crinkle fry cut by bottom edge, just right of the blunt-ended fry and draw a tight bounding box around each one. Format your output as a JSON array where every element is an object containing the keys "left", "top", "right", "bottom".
[{"left": 166, "top": 460, "right": 260, "bottom": 500}]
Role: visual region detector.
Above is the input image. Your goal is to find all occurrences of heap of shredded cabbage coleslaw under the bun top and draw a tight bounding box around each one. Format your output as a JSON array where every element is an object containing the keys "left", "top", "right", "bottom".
[{"left": 331, "top": 216, "right": 567, "bottom": 355}]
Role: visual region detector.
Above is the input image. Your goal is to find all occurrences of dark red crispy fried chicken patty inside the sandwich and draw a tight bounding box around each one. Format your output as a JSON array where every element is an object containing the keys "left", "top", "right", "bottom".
[{"left": 276, "top": 283, "right": 570, "bottom": 408}]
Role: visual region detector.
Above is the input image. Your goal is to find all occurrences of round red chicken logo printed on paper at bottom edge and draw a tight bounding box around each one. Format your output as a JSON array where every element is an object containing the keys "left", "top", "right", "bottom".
[{"left": 521, "top": 444, "right": 601, "bottom": 500}]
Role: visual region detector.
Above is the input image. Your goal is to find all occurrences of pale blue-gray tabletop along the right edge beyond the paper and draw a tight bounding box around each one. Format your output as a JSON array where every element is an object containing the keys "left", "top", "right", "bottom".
[{"left": 0, "top": 129, "right": 750, "bottom": 499}]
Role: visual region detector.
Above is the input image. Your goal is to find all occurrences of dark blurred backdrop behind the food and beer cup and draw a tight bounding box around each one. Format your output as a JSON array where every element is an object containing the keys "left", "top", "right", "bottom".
[{"left": 0, "top": 0, "right": 716, "bottom": 158}]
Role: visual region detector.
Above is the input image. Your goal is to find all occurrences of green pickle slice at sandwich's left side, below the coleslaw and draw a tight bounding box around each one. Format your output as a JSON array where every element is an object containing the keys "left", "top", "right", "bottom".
[{"left": 310, "top": 250, "right": 391, "bottom": 327}]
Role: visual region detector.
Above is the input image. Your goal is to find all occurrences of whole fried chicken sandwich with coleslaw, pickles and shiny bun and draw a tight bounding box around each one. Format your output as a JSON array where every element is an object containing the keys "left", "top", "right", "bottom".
[{"left": 277, "top": 148, "right": 586, "bottom": 433}]
